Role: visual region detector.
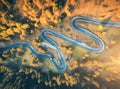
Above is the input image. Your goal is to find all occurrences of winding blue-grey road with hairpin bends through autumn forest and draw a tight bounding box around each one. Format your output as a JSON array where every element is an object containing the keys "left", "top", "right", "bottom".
[{"left": 0, "top": 16, "right": 120, "bottom": 71}]
